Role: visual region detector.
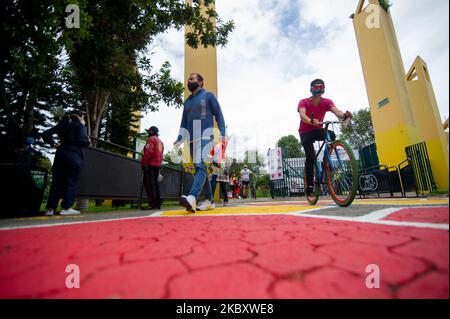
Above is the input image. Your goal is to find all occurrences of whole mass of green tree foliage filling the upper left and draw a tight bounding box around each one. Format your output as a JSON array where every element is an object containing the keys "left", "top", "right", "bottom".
[{"left": 0, "top": 0, "right": 234, "bottom": 160}]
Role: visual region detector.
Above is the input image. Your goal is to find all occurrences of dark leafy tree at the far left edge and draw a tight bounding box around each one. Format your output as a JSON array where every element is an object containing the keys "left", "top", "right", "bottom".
[{"left": 0, "top": 0, "right": 89, "bottom": 158}]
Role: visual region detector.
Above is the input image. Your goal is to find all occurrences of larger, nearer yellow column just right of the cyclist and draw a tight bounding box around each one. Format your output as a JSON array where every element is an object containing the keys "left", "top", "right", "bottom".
[{"left": 353, "top": 0, "right": 422, "bottom": 166}]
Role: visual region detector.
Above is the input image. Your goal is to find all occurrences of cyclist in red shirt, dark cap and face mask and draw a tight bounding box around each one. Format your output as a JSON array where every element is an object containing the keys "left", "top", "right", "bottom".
[{"left": 297, "top": 79, "right": 353, "bottom": 196}]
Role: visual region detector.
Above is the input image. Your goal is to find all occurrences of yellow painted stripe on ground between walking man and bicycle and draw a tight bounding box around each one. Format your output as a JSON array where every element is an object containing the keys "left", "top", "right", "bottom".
[{"left": 161, "top": 206, "right": 321, "bottom": 216}]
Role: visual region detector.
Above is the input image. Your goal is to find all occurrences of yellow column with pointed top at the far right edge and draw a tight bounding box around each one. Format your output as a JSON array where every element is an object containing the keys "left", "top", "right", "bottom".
[{"left": 406, "top": 57, "right": 449, "bottom": 190}]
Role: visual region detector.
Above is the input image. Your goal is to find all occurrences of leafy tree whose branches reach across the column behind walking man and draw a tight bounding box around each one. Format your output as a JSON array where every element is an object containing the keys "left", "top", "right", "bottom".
[{"left": 65, "top": 0, "right": 234, "bottom": 141}]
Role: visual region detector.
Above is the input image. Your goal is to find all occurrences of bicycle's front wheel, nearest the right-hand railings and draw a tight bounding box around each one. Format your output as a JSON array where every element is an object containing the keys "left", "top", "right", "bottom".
[{"left": 325, "top": 141, "right": 358, "bottom": 207}]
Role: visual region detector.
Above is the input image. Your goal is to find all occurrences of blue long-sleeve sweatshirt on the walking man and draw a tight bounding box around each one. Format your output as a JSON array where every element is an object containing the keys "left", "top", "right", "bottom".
[{"left": 177, "top": 89, "right": 226, "bottom": 142}]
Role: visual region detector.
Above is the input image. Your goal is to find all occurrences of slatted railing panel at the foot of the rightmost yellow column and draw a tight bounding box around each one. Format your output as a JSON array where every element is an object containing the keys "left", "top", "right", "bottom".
[{"left": 405, "top": 142, "right": 437, "bottom": 194}]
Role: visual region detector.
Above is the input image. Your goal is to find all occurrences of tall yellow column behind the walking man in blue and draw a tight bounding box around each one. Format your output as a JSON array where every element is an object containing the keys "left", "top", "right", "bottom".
[{"left": 184, "top": 0, "right": 220, "bottom": 201}]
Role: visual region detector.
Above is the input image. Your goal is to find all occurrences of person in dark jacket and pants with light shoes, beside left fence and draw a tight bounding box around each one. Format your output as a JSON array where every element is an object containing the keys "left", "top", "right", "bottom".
[{"left": 42, "top": 111, "right": 89, "bottom": 216}]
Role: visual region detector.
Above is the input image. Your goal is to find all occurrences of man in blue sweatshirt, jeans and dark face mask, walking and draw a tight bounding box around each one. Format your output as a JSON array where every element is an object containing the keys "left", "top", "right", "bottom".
[{"left": 174, "top": 73, "right": 225, "bottom": 213}]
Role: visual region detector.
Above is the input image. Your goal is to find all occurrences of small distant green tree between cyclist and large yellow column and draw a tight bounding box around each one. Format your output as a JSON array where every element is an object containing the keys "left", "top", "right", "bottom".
[{"left": 339, "top": 108, "right": 375, "bottom": 149}]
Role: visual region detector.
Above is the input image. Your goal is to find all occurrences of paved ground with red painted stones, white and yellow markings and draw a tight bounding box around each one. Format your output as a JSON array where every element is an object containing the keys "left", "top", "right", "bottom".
[{"left": 0, "top": 199, "right": 449, "bottom": 299}]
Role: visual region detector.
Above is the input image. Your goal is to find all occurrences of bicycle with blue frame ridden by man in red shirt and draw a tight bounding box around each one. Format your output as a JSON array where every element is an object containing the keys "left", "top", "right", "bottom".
[{"left": 303, "top": 121, "right": 359, "bottom": 207}]
